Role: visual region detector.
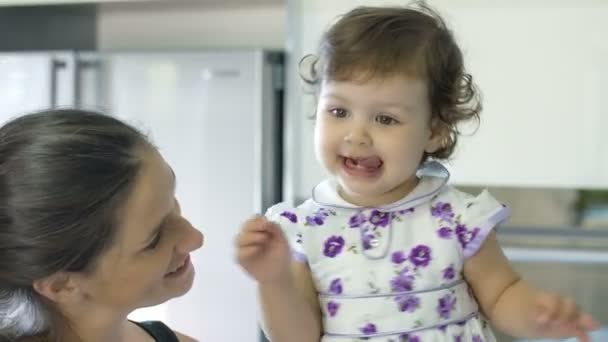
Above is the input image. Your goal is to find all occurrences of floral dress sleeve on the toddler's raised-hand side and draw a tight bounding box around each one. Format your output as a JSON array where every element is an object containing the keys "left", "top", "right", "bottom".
[{"left": 265, "top": 203, "right": 308, "bottom": 262}]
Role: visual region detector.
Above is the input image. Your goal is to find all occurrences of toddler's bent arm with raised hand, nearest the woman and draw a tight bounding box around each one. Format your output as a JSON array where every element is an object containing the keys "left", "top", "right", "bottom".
[{"left": 236, "top": 217, "right": 321, "bottom": 342}]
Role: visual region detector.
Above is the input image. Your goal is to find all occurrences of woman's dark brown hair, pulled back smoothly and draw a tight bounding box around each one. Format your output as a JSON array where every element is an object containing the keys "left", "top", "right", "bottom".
[{"left": 0, "top": 109, "right": 149, "bottom": 341}]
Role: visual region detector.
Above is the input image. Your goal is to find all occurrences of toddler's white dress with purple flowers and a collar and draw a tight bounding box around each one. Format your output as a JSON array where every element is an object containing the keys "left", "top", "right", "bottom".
[{"left": 266, "top": 163, "right": 509, "bottom": 342}]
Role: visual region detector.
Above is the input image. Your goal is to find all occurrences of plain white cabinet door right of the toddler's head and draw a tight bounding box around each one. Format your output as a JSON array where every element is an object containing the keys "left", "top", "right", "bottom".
[{"left": 448, "top": 4, "right": 608, "bottom": 188}]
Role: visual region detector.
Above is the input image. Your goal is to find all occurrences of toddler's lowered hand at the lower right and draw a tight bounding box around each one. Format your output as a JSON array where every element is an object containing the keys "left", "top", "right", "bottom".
[{"left": 533, "top": 293, "right": 599, "bottom": 342}]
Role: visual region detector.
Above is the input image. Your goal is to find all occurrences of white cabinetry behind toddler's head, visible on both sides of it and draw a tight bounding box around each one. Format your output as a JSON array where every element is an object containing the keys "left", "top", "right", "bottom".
[{"left": 286, "top": 0, "right": 608, "bottom": 202}]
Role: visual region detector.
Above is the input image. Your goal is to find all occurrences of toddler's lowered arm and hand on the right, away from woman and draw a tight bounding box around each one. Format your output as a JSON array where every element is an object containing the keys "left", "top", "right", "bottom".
[{"left": 464, "top": 232, "right": 597, "bottom": 341}]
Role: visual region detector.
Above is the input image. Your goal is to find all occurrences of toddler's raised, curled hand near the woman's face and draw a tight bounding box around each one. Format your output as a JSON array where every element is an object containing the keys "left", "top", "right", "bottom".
[{"left": 236, "top": 216, "right": 291, "bottom": 283}]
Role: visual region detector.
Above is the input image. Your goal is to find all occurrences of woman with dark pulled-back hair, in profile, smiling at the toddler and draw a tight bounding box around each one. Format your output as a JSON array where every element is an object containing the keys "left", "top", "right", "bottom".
[{"left": 0, "top": 110, "right": 203, "bottom": 342}]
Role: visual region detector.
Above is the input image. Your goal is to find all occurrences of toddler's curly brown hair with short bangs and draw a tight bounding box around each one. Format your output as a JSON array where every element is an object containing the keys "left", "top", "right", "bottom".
[{"left": 300, "top": 2, "right": 481, "bottom": 160}]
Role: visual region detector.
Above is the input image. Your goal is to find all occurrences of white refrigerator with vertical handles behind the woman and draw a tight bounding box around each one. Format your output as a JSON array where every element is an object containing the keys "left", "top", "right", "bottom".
[{"left": 0, "top": 50, "right": 283, "bottom": 342}]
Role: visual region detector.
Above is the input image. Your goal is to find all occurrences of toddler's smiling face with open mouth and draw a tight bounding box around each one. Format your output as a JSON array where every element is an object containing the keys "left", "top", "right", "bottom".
[{"left": 315, "top": 76, "right": 439, "bottom": 206}]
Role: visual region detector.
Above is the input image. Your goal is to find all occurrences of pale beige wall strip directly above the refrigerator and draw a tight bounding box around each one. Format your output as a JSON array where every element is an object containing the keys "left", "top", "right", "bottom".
[{"left": 97, "top": 0, "right": 286, "bottom": 49}]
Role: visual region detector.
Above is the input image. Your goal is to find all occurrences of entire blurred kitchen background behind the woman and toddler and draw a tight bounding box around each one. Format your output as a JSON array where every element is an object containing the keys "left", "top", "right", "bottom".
[{"left": 0, "top": 0, "right": 608, "bottom": 342}]
